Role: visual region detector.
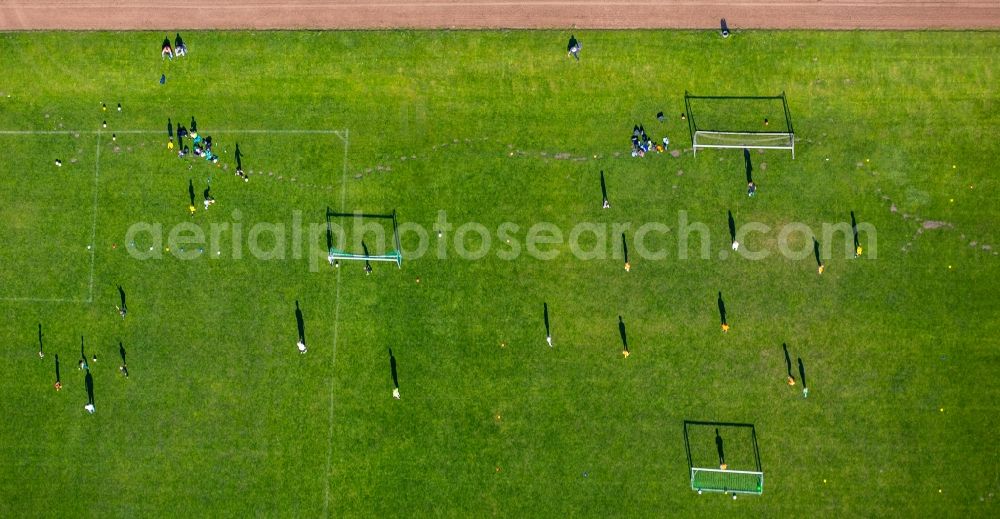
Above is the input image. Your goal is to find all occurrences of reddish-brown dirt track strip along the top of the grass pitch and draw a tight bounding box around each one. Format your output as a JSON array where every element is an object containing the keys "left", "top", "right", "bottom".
[{"left": 0, "top": 0, "right": 1000, "bottom": 31}]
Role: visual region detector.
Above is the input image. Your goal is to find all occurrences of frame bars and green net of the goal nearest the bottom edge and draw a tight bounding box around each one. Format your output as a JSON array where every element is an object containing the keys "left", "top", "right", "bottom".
[{"left": 684, "top": 420, "right": 764, "bottom": 495}]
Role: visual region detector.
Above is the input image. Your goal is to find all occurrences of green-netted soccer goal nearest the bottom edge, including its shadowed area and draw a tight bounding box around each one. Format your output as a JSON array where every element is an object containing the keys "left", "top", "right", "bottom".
[{"left": 684, "top": 420, "right": 764, "bottom": 495}]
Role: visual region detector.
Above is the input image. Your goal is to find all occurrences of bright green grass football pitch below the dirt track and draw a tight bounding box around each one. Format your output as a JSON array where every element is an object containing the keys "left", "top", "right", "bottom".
[{"left": 0, "top": 31, "right": 1000, "bottom": 517}]
